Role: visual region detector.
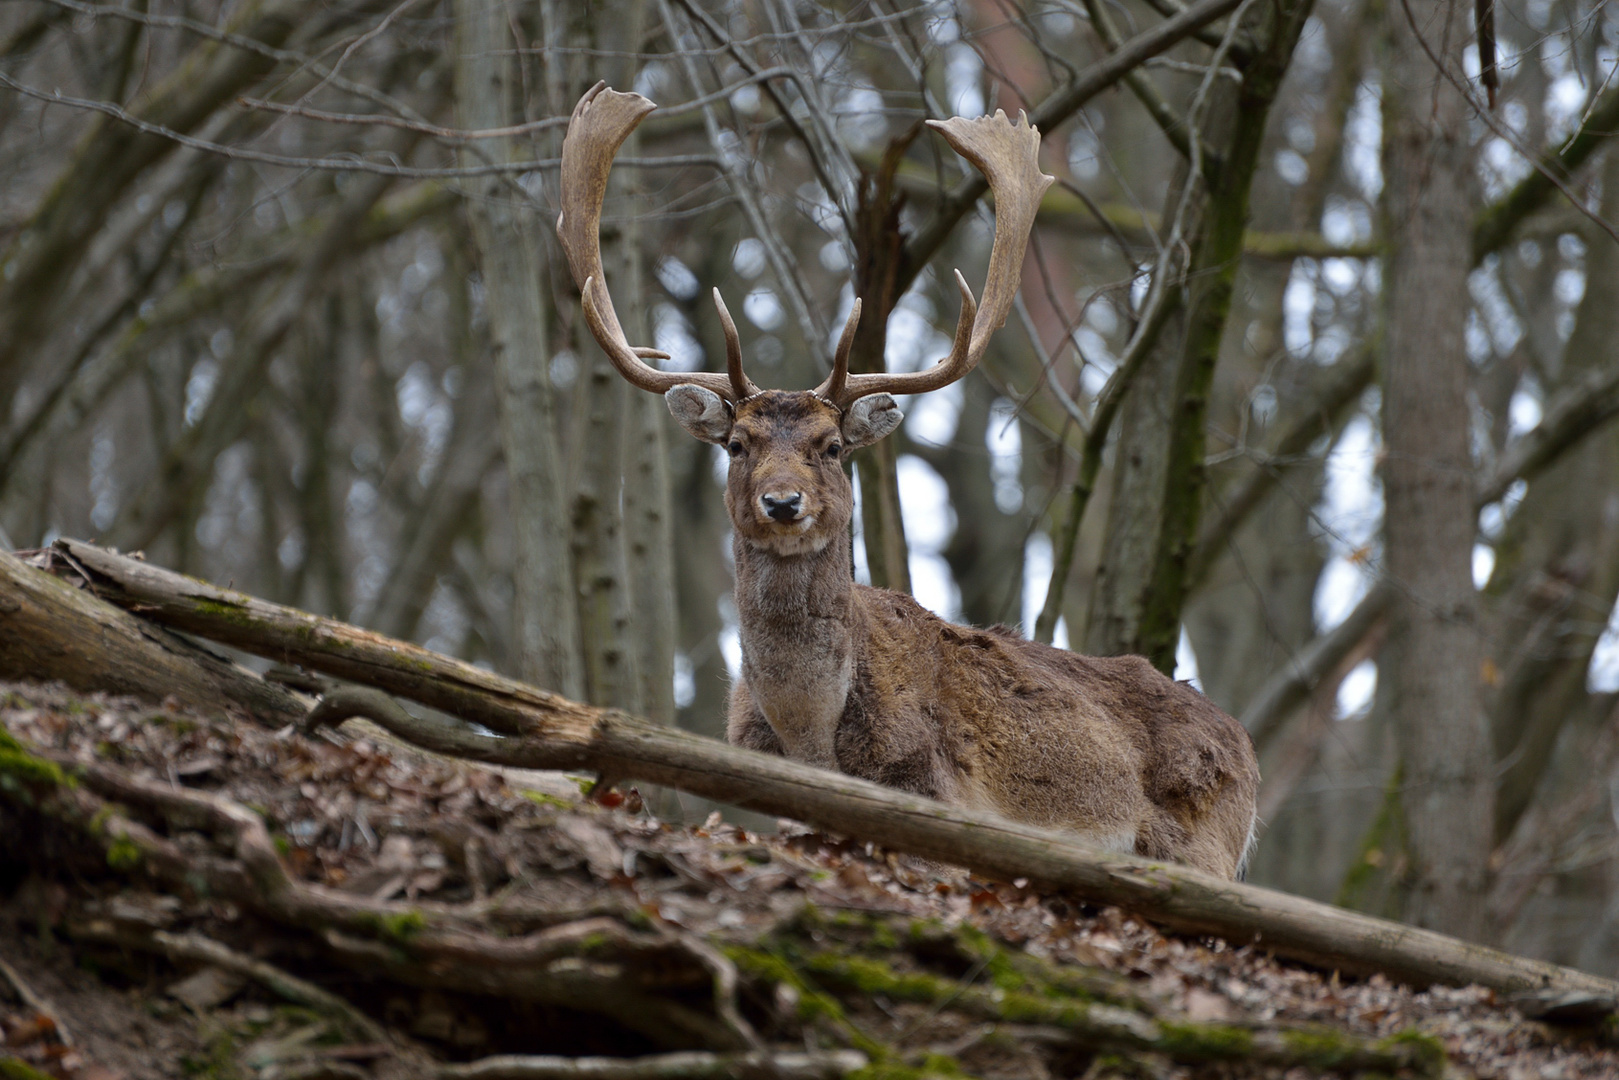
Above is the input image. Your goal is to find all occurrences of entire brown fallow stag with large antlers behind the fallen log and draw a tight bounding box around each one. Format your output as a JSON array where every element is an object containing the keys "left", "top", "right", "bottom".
[{"left": 557, "top": 84, "right": 1260, "bottom": 878}]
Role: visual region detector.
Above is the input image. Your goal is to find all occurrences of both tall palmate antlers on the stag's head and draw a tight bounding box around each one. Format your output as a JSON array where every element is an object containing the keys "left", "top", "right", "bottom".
[{"left": 557, "top": 83, "right": 1054, "bottom": 410}]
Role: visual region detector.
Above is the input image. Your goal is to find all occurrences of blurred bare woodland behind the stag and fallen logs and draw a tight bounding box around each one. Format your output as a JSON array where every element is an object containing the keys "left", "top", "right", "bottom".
[{"left": 0, "top": 0, "right": 1619, "bottom": 975}]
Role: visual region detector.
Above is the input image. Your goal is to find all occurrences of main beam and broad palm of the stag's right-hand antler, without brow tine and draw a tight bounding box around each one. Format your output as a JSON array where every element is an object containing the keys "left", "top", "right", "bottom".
[{"left": 832, "top": 108, "right": 1056, "bottom": 408}]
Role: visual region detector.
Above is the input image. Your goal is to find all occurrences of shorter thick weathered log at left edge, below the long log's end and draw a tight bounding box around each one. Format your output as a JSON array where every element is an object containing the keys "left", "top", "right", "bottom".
[{"left": 0, "top": 552, "right": 308, "bottom": 727}]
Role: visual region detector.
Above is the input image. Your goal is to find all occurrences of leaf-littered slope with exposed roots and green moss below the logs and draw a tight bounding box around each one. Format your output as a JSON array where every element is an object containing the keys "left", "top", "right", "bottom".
[{"left": 0, "top": 685, "right": 1619, "bottom": 1080}]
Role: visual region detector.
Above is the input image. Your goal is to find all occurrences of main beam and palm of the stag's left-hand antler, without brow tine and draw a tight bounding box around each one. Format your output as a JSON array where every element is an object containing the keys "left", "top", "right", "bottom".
[{"left": 557, "top": 83, "right": 732, "bottom": 398}]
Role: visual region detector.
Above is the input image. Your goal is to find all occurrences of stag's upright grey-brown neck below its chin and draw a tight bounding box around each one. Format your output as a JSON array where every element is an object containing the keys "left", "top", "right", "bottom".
[{"left": 733, "top": 529, "right": 855, "bottom": 769}]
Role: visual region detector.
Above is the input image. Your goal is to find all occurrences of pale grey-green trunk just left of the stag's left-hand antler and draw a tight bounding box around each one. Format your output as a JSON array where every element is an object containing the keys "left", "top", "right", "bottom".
[{"left": 455, "top": 0, "right": 584, "bottom": 696}]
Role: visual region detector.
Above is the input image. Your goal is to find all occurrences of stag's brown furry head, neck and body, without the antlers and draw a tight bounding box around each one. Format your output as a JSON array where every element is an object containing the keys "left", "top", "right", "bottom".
[{"left": 683, "top": 387, "right": 1260, "bottom": 878}]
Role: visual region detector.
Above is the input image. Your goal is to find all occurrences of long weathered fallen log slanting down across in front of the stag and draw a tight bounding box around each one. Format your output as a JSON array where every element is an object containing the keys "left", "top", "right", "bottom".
[{"left": 28, "top": 541, "right": 1619, "bottom": 1012}]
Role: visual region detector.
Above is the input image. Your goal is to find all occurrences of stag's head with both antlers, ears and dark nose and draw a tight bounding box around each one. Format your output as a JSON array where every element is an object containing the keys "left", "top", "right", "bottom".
[{"left": 557, "top": 83, "right": 1052, "bottom": 555}]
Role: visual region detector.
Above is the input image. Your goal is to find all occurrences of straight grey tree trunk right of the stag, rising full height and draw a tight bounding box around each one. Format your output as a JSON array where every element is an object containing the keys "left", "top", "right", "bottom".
[{"left": 1381, "top": 0, "right": 1493, "bottom": 939}]
